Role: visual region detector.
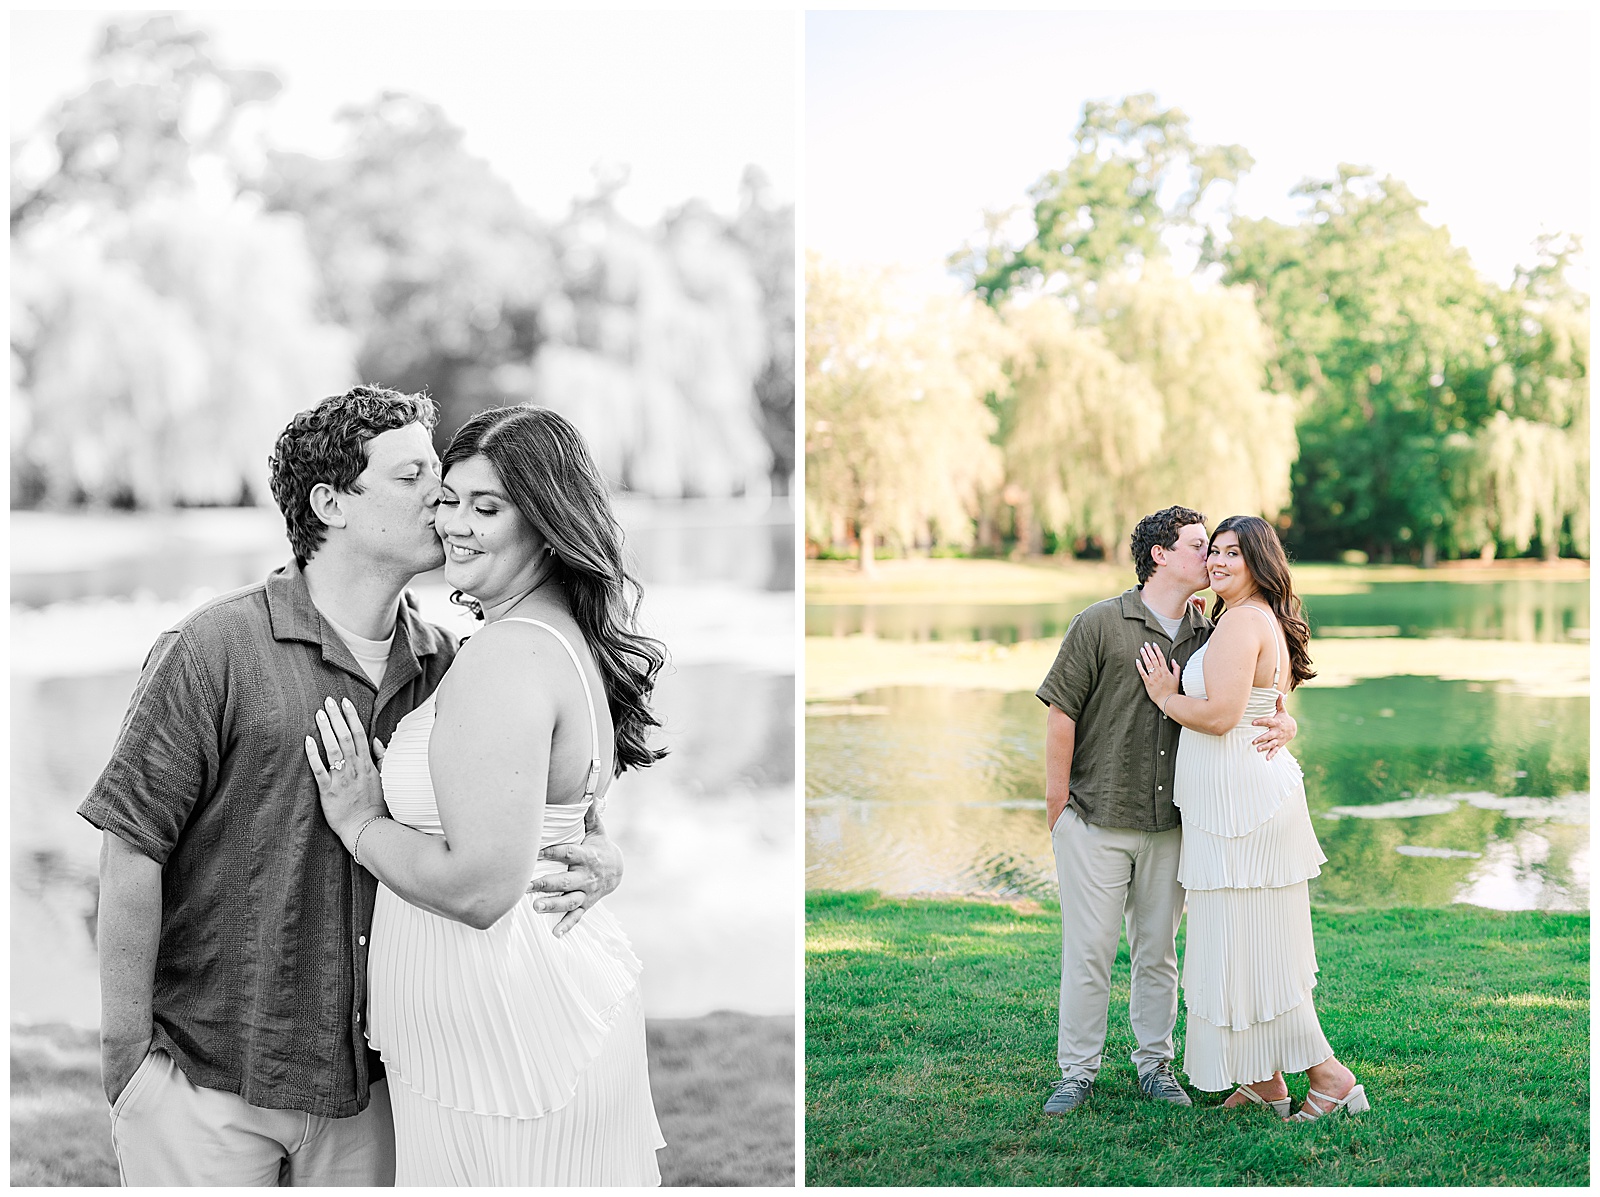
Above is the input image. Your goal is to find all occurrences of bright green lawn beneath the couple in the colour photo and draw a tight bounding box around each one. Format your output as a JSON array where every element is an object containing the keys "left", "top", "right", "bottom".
[{"left": 805, "top": 893, "right": 1589, "bottom": 1186}]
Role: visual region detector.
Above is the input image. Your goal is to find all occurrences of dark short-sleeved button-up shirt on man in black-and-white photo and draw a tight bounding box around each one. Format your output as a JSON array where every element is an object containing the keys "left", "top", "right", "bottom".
[{"left": 78, "top": 562, "right": 456, "bottom": 1119}]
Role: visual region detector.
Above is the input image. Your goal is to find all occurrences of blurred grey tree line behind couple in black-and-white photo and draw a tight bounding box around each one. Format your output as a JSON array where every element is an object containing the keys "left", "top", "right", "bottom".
[{"left": 11, "top": 16, "right": 795, "bottom": 509}]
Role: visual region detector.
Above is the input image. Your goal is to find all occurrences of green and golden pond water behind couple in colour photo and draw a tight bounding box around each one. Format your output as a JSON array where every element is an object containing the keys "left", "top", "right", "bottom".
[{"left": 805, "top": 579, "right": 1589, "bottom": 909}]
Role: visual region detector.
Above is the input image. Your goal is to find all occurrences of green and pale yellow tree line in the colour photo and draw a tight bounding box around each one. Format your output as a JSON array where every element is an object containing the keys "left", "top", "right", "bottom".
[{"left": 805, "top": 94, "right": 1589, "bottom": 568}]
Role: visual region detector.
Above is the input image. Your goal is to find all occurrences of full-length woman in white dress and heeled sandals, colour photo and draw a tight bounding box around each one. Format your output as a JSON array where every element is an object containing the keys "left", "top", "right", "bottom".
[{"left": 1138, "top": 515, "right": 1368, "bottom": 1122}]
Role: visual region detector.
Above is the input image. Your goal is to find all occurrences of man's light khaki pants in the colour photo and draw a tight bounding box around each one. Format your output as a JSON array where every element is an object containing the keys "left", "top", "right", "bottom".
[{"left": 1050, "top": 807, "right": 1184, "bottom": 1080}]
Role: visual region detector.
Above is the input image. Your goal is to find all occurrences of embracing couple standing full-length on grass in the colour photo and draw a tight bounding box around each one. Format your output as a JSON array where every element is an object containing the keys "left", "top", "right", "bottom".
[{"left": 1038, "top": 507, "right": 1366, "bottom": 1122}]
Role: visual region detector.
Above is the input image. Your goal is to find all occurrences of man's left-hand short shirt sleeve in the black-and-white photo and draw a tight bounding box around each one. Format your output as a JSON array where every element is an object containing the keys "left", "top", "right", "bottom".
[{"left": 78, "top": 631, "right": 219, "bottom": 864}]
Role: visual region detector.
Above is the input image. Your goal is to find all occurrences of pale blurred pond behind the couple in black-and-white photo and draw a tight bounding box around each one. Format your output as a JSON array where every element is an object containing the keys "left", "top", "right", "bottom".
[{"left": 11, "top": 504, "right": 795, "bottom": 1026}]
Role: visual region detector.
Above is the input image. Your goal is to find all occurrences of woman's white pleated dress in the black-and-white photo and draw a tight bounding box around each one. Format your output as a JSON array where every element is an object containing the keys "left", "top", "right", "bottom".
[{"left": 366, "top": 619, "right": 664, "bottom": 1186}]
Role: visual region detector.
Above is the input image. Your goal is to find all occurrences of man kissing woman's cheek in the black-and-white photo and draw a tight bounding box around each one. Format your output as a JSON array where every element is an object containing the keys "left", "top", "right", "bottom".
[{"left": 78, "top": 387, "right": 621, "bottom": 1186}]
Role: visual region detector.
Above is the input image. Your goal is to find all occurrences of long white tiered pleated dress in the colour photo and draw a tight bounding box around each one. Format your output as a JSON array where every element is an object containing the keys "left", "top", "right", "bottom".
[{"left": 1173, "top": 620, "right": 1333, "bottom": 1093}]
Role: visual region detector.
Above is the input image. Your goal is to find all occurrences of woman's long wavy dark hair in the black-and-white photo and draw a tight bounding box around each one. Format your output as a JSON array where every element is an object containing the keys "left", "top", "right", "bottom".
[{"left": 440, "top": 403, "right": 667, "bottom": 775}]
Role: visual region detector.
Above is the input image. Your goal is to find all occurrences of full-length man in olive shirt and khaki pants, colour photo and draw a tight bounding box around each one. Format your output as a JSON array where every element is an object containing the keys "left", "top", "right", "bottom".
[{"left": 1037, "top": 507, "right": 1296, "bottom": 1114}]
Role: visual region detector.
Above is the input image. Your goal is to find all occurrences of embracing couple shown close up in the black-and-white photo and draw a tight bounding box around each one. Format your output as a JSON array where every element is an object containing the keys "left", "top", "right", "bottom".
[{"left": 78, "top": 387, "right": 666, "bottom": 1186}]
